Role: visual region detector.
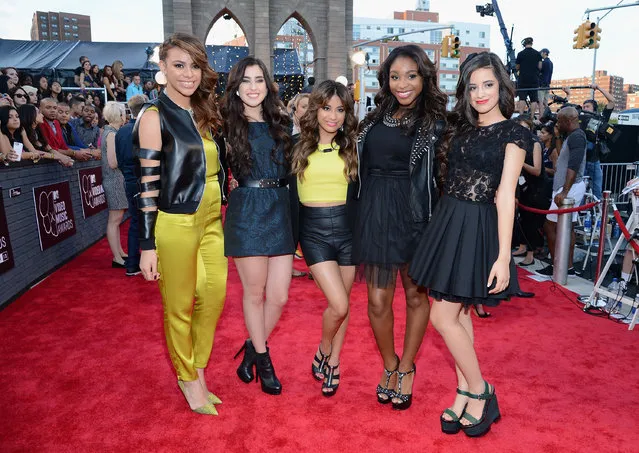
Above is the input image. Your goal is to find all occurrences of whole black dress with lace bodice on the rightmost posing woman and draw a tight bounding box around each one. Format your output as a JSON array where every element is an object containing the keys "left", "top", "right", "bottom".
[{"left": 409, "top": 120, "right": 533, "bottom": 306}]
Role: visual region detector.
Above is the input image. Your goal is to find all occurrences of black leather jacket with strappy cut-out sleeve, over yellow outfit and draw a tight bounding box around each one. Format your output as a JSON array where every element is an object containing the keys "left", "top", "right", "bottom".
[{"left": 133, "top": 93, "right": 228, "bottom": 250}]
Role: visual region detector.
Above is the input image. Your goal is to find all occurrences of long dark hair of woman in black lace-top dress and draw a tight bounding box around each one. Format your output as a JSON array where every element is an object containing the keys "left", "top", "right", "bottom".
[{"left": 437, "top": 52, "right": 515, "bottom": 185}]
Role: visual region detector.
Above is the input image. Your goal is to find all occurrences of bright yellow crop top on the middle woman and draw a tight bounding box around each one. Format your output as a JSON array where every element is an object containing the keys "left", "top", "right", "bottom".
[{"left": 297, "top": 144, "right": 348, "bottom": 204}]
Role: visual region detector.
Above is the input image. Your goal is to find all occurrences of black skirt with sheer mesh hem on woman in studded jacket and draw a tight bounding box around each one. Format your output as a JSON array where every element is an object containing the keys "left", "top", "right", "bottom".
[{"left": 353, "top": 172, "right": 426, "bottom": 288}]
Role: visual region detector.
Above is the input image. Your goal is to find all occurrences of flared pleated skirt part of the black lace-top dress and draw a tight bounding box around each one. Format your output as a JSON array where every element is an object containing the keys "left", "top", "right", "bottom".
[{"left": 409, "top": 196, "right": 519, "bottom": 306}]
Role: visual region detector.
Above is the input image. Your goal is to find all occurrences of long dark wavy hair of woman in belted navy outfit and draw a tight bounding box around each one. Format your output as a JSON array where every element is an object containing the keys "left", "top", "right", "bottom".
[{"left": 222, "top": 56, "right": 292, "bottom": 176}]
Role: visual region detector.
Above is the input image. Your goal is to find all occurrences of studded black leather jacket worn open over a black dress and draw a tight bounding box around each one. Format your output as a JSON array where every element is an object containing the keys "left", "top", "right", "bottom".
[{"left": 356, "top": 119, "right": 446, "bottom": 222}]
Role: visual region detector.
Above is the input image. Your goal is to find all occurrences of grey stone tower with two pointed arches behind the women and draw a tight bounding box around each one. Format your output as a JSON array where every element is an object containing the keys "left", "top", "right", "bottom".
[{"left": 162, "top": 0, "right": 353, "bottom": 81}]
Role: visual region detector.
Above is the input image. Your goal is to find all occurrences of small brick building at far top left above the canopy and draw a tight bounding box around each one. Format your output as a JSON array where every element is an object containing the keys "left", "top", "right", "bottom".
[{"left": 31, "top": 11, "right": 91, "bottom": 41}]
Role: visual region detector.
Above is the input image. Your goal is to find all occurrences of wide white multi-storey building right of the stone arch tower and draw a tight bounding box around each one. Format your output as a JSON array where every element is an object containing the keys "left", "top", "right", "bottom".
[{"left": 352, "top": 6, "right": 490, "bottom": 107}]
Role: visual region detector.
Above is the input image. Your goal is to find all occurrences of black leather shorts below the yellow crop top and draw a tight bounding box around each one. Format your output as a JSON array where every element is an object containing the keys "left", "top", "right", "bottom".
[{"left": 300, "top": 205, "right": 354, "bottom": 266}]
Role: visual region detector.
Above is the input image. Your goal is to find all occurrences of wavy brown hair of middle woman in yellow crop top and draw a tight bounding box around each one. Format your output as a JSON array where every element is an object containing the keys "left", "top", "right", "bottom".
[{"left": 291, "top": 80, "right": 357, "bottom": 181}]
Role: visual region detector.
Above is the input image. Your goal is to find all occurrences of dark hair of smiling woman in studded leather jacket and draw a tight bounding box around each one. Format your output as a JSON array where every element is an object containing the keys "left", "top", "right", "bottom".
[{"left": 362, "top": 44, "right": 448, "bottom": 133}]
